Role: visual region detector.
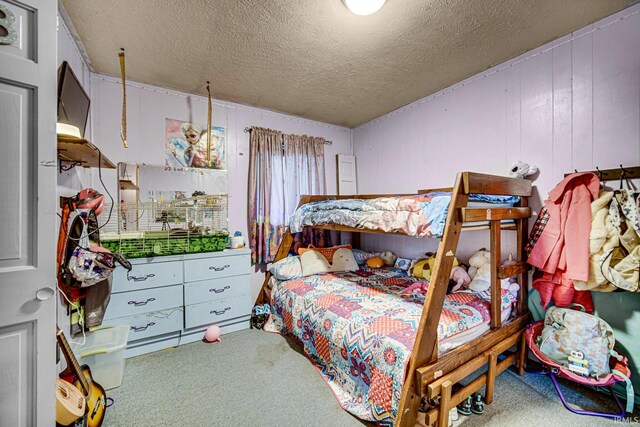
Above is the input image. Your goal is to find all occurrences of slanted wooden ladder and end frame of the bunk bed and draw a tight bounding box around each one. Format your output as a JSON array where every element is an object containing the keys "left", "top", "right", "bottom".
[{"left": 396, "top": 172, "right": 531, "bottom": 427}]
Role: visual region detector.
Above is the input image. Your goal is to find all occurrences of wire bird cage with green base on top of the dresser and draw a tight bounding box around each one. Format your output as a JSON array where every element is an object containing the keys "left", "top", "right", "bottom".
[{"left": 99, "top": 194, "right": 229, "bottom": 258}]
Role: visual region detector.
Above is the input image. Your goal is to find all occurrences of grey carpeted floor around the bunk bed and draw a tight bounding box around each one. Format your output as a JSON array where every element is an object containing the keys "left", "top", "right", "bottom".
[{"left": 103, "top": 330, "right": 640, "bottom": 427}]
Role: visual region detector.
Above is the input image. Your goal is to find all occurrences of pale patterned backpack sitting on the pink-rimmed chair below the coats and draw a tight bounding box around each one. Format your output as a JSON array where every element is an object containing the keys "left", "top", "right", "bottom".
[{"left": 538, "top": 307, "right": 617, "bottom": 378}]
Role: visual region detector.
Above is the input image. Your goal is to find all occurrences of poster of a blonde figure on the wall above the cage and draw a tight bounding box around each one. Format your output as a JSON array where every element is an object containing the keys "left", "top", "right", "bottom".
[{"left": 165, "top": 119, "right": 227, "bottom": 170}]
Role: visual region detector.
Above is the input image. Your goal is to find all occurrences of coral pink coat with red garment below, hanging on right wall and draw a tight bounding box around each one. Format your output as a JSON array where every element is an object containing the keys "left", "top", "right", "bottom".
[{"left": 528, "top": 172, "right": 600, "bottom": 312}]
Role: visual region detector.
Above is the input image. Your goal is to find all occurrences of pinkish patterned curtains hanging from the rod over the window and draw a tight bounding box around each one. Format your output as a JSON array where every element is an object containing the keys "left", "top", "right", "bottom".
[{"left": 249, "top": 127, "right": 325, "bottom": 264}]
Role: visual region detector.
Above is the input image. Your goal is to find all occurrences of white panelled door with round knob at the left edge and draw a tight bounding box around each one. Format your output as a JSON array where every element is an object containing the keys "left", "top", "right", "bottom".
[{"left": 0, "top": 0, "right": 57, "bottom": 427}]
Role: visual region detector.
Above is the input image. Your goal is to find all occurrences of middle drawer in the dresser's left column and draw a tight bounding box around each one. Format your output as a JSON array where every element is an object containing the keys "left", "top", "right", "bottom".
[{"left": 104, "top": 285, "right": 183, "bottom": 319}]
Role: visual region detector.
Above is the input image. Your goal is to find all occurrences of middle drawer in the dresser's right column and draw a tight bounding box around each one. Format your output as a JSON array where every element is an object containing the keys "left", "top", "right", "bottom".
[{"left": 184, "top": 274, "right": 250, "bottom": 305}]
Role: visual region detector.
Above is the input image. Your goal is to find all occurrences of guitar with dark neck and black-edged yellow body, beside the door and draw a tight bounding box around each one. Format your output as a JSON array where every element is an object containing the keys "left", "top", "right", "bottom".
[{"left": 56, "top": 326, "right": 107, "bottom": 427}]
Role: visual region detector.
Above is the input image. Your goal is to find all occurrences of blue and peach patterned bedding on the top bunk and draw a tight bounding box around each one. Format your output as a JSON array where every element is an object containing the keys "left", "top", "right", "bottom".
[{"left": 289, "top": 192, "right": 519, "bottom": 237}]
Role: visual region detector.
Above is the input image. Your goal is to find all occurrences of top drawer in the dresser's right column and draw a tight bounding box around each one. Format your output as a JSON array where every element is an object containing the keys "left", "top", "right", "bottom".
[{"left": 184, "top": 255, "right": 251, "bottom": 282}]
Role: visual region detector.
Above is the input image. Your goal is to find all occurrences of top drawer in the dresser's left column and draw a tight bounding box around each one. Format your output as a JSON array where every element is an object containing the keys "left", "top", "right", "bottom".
[{"left": 112, "top": 261, "right": 182, "bottom": 294}]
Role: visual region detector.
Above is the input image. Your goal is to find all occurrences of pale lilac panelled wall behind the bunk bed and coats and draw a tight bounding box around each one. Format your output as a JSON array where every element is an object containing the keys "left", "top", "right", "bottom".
[{"left": 354, "top": 5, "right": 640, "bottom": 262}]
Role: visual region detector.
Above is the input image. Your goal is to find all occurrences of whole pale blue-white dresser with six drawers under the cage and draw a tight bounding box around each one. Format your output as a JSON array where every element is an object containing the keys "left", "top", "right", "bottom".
[{"left": 103, "top": 249, "right": 252, "bottom": 357}]
